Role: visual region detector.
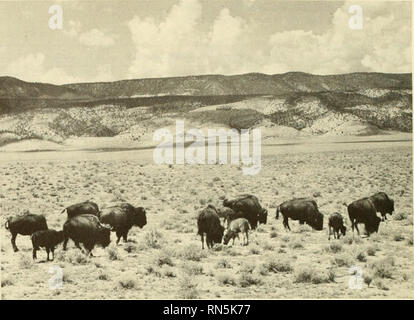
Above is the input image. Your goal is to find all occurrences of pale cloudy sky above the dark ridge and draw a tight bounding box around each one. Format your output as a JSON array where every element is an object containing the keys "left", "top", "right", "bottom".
[{"left": 0, "top": 0, "right": 412, "bottom": 84}]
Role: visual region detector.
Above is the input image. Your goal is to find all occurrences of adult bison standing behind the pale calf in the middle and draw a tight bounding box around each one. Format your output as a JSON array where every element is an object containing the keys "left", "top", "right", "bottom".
[{"left": 223, "top": 194, "right": 267, "bottom": 229}]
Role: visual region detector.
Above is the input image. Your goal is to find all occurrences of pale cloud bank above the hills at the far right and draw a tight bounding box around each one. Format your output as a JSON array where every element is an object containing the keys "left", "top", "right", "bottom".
[{"left": 265, "top": 3, "right": 411, "bottom": 74}]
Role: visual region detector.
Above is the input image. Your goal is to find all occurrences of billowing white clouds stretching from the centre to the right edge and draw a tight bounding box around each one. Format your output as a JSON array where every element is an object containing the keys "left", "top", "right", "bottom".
[{"left": 127, "top": 0, "right": 411, "bottom": 78}]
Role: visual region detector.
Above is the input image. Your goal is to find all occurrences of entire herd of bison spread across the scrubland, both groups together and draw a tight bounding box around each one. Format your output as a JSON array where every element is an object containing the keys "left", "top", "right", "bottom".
[{"left": 5, "top": 192, "right": 394, "bottom": 260}]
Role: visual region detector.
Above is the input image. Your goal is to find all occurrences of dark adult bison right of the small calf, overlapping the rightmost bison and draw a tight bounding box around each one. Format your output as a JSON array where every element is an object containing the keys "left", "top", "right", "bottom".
[{"left": 348, "top": 198, "right": 381, "bottom": 237}]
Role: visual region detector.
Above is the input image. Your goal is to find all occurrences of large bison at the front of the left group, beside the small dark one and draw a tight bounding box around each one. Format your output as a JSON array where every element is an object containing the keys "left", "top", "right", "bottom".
[{"left": 63, "top": 214, "right": 111, "bottom": 256}]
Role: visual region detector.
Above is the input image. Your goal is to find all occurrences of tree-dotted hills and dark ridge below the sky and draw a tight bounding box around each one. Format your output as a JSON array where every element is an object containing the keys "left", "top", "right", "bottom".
[{"left": 0, "top": 72, "right": 412, "bottom": 145}]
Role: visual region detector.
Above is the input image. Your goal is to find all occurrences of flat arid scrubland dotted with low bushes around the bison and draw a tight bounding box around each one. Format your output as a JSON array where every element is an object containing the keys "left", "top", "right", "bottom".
[{"left": 0, "top": 137, "right": 414, "bottom": 299}]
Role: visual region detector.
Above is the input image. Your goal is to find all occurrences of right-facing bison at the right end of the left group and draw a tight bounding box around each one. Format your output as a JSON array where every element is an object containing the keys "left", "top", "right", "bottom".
[{"left": 100, "top": 202, "right": 147, "bottom": 243}]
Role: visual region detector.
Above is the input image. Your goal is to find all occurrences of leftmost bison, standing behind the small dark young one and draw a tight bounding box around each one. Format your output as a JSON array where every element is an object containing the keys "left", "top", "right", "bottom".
[{"left": 4, "top": 212, "right": 47, "bottom": 252}]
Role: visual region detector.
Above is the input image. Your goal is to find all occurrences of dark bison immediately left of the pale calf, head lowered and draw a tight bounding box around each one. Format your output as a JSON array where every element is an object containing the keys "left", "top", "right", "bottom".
[{"left": 197, "top": 204, "right": 224, "bottom": 249}]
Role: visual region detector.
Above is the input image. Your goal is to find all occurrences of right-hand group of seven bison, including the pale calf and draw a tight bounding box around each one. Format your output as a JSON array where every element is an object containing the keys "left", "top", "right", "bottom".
[{"left": 197, "top": 192, "right": 394, "bottom": 249}]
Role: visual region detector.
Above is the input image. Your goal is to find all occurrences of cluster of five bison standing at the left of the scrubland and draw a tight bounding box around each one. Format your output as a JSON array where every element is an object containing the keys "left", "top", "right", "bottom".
[{"left": 5, "top": 201, "right": 147, "bottom": 260}]
